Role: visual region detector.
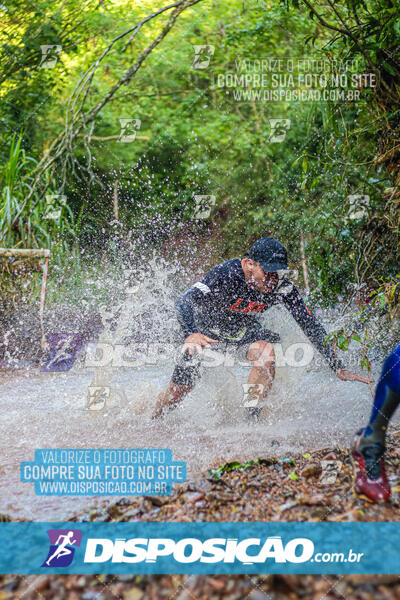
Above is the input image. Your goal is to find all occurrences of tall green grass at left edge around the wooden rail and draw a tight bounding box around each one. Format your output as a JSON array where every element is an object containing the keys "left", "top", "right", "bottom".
[{"left": 0, "top": 135, "right": 81, "bottom": 304}]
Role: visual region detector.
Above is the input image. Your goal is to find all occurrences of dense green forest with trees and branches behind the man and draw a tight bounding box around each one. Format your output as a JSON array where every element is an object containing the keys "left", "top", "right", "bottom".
[{"left": 0, "top": 0, "right": 400, "bottom": 306}]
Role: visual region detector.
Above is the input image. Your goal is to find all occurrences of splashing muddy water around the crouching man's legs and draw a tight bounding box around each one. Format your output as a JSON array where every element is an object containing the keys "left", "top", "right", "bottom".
[{"left": 0, "top": 256, "right": 396, "bottom": 520}]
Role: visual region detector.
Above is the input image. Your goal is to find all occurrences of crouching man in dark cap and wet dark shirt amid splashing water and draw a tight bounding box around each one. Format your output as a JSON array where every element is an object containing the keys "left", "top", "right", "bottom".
[{"left": 153, "top": 238, "right": 371, "bottom": 419}]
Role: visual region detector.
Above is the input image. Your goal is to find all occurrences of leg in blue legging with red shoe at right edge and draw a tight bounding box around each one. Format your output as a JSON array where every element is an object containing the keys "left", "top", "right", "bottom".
[{"left": 352, "top": 344, "right": 400, "bottom": 501}]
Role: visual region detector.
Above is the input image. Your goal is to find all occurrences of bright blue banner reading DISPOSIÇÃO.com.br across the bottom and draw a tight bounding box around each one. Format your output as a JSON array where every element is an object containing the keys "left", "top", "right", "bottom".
[{"left": 0, "top": 522, "right": 400, "bottom": 574}]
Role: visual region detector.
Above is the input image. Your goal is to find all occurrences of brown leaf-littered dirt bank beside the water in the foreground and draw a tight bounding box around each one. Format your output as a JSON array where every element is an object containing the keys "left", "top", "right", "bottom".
[{"left": 0, "top": 428, "right": 400, "bottom": 600}]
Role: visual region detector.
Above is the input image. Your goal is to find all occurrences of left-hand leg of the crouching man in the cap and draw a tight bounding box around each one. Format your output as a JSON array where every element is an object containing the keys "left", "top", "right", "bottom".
[{"left": 151, "top": 352, "right": 200, "bottom": 419}]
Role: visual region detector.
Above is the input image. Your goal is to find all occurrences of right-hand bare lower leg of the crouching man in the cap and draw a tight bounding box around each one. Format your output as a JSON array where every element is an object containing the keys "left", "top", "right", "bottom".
[{"left": 247, "top": 340, "right": 275, "bottom": 418}]
